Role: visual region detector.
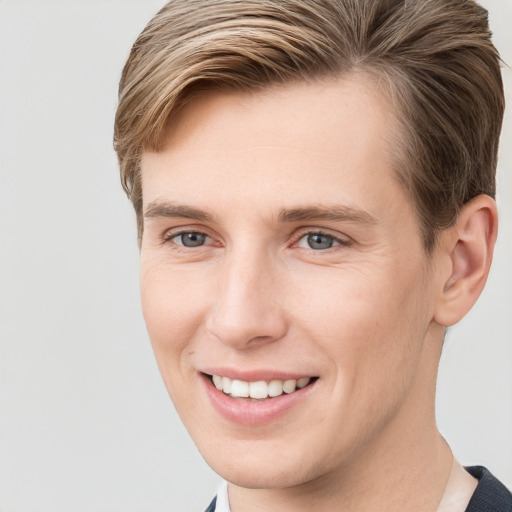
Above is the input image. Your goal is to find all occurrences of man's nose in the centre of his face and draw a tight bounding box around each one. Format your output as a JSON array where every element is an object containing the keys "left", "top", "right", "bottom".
[{"left": 206, "top": 247, "right": 287, "bottom": 350}]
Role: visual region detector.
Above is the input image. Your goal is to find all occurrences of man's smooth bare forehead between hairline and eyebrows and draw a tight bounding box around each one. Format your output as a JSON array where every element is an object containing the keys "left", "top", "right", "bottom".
[{"left": 142, "top": 73, "right": 408, "bottom": 224}]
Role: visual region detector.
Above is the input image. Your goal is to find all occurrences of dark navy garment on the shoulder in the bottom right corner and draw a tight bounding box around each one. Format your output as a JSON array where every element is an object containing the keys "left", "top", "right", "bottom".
[{"left": 466, "top": 466, "right": 512, "bottom": 512}]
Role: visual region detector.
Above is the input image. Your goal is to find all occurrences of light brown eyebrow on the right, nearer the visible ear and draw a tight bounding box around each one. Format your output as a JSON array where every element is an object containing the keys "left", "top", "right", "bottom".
[{"left": 279, "top": 205, "right": 377, "bottom": 224}]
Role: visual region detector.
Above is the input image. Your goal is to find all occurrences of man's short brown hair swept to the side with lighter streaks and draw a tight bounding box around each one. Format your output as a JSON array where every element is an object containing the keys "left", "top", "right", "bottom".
[{"left": 114, "top": 0, "right": 504, "bottom": 252}]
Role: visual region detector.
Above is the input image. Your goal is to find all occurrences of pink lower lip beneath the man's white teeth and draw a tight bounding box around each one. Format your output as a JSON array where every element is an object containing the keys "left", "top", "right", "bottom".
[{"left": 202, "top": 374, "right": 318, "bottom": 425}]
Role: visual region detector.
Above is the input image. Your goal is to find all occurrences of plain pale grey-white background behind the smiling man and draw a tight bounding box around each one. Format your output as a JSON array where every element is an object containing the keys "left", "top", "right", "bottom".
[{"left": 0, "top": 0, "right": 512, "bottom": 512}]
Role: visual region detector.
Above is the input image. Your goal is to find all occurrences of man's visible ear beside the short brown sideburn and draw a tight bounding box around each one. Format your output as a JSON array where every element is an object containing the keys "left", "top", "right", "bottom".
[{"left": 434, "top": 195, "right": 498, "bottom": 327}]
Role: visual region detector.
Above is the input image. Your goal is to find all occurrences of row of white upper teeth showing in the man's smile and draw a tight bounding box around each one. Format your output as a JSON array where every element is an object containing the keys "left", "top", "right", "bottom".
[{"left": 212, "top": 375, "right": 311, "bottom": 400}]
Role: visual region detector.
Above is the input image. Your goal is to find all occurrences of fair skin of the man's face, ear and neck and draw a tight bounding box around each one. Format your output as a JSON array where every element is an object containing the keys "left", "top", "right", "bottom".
[{"left": 141, "top": 75, "right": 496, "bottom": 512}]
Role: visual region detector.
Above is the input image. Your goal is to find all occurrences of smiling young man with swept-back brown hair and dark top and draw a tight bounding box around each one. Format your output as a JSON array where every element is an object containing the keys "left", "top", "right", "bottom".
[{"left": 115, "top": 0, "right": 512, "bottom": 512}]
